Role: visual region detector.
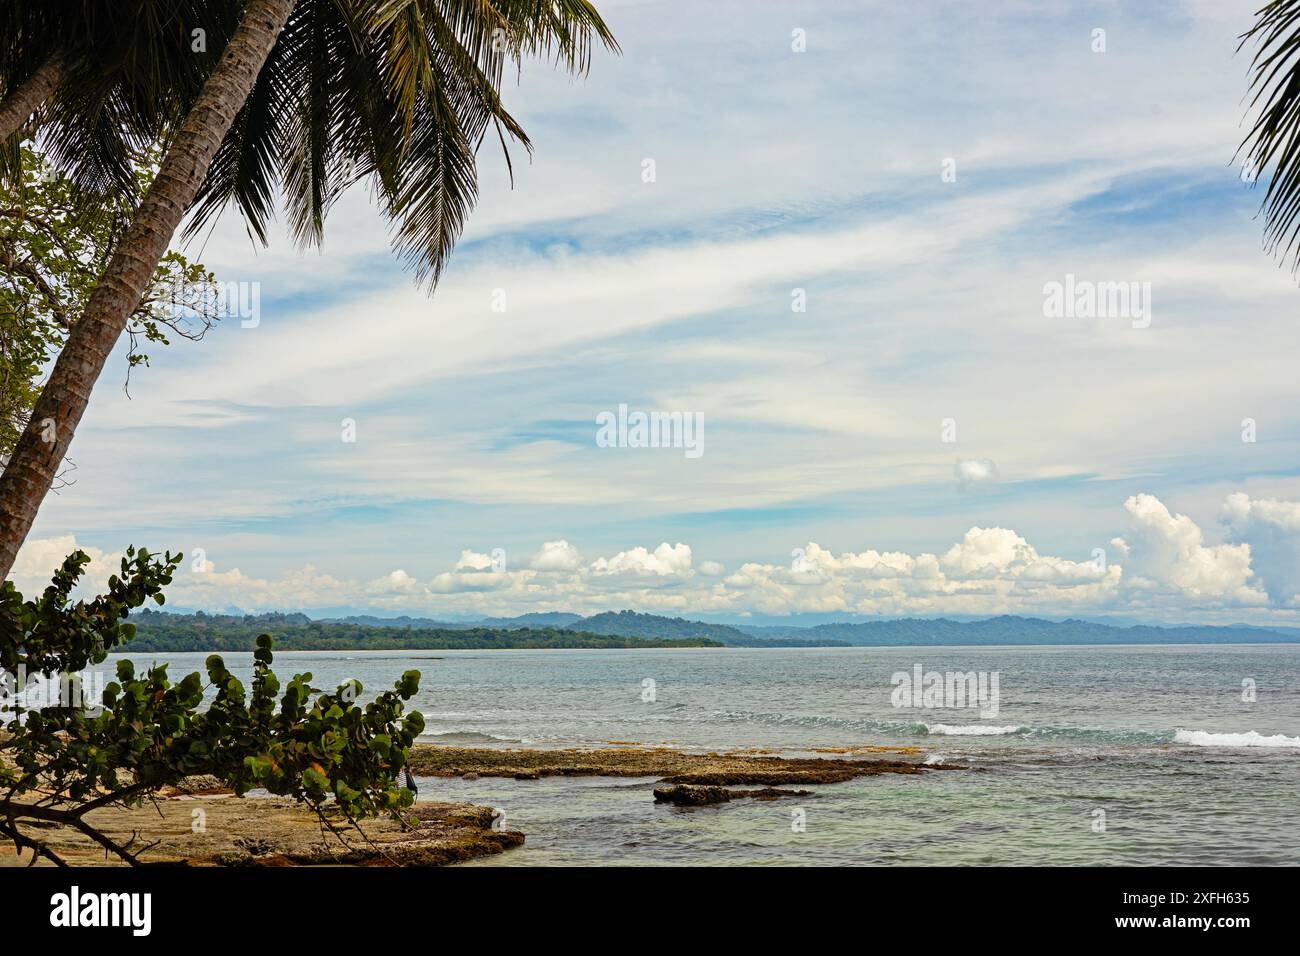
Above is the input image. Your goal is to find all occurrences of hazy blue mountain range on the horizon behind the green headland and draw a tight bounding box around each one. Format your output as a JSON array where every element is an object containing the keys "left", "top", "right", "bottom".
[{"left": 133, "top": 610, "right": 1300, "bottom": 649}]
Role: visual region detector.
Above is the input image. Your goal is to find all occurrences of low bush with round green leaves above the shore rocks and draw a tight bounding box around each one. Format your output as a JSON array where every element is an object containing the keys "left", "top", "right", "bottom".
[{"left": 0, "top": 548, "right": 424, "bottom": 862}]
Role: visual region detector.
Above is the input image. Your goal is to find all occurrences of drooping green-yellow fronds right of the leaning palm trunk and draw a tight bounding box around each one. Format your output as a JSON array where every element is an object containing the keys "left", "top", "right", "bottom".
[{"left": 175, "top": 0, "right": 618, "bottom": 286}]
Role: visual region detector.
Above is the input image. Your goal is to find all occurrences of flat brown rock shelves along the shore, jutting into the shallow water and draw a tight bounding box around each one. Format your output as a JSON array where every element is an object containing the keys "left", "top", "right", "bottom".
[{"left": 0, "top": 744, "right": 963, "bottom": 866}]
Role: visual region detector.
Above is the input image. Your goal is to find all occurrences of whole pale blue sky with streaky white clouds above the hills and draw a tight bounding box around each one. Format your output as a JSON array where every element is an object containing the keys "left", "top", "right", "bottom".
[{"left": 14, "top": 0, "right": 1300, "bottom": 624}]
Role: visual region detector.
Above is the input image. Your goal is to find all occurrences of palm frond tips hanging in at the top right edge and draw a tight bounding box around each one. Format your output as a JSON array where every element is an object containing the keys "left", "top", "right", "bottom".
[{"left": 1242, "top": 0, "right": 1300, "bottom": 272}]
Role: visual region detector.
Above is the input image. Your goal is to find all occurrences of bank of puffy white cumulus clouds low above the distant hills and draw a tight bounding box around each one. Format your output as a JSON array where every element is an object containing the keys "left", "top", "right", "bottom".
[{"left": 14, "top": 494, "right": 1300, "bottom": 623}]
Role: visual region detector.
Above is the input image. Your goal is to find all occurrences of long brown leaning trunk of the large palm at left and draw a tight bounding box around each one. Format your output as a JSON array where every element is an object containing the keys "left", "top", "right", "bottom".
[{"left": 0, "top": 0, "right": 295, "bottom": 579}]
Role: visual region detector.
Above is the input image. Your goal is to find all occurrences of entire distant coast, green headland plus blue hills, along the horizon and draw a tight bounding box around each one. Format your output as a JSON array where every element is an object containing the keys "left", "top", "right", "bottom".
[{"left": 125, "top": 611, "right": 1300, "bottom": 653}]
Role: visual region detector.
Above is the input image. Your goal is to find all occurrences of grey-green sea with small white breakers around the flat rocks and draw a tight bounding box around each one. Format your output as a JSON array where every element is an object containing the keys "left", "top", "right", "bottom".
[{"left": 109, "top": 645, "right": 1300, "bottom": 866}]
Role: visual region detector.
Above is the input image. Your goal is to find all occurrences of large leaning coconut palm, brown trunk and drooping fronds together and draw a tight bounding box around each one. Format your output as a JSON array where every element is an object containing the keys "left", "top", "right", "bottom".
[{"left": 0, "top": 0, "right": 618, "bottom": 576}]
